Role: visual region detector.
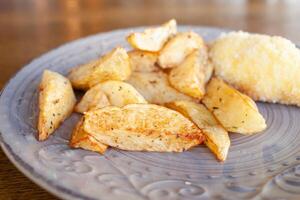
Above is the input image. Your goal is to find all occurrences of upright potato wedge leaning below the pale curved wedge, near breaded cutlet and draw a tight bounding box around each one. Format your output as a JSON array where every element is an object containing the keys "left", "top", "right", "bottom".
[{"left": 169, "top": 50, "right": 212, "bottom": 99}]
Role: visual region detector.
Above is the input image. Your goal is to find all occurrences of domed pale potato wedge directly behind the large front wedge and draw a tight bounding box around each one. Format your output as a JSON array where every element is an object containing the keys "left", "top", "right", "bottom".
[{"left": 75, "top": 81, "right": 147, "bottom": 113}]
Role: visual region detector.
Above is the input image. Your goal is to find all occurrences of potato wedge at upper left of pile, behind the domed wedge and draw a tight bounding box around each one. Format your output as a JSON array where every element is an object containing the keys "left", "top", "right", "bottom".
[{"left": 68, "top": 47, "right": 131, "bottom": 90}]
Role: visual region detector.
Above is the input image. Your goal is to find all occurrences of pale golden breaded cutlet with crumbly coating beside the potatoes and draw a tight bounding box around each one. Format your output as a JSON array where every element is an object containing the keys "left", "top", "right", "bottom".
[{"left": 210, "top": 31, "right": 300, "bottom": 106}]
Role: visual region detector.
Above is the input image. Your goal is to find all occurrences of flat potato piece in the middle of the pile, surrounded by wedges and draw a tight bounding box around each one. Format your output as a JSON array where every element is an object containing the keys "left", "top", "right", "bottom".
[{"left": 127, "top": 72, "right": 196, "bottom": 105}]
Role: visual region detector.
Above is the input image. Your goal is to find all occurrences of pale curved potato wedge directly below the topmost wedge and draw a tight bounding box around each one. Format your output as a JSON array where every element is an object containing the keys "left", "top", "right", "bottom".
[{"left": 158, "top": 32, "right": 206, "bottom": 68}]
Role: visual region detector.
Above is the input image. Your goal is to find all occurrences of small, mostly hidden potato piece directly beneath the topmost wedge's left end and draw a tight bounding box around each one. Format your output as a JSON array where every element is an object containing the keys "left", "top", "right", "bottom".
[{"left": 128, "top": 50, "right": 160, "bottom": 72}]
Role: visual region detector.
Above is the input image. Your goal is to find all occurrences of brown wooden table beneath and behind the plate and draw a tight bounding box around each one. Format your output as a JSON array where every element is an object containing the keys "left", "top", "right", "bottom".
[{"left": 0, "top": 0, "right": 300, "bottom": 200}]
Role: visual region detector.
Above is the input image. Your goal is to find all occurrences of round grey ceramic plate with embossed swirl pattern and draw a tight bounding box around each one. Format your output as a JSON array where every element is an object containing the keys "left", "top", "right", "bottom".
[{"left": 0, "top": 26, "right": 300, "bottom": 200}]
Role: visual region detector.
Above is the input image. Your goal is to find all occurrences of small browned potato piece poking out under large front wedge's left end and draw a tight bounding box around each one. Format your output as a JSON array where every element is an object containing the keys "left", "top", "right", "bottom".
[{"left": 69, "top": 119, "right": 108, "bottom": 154}]
